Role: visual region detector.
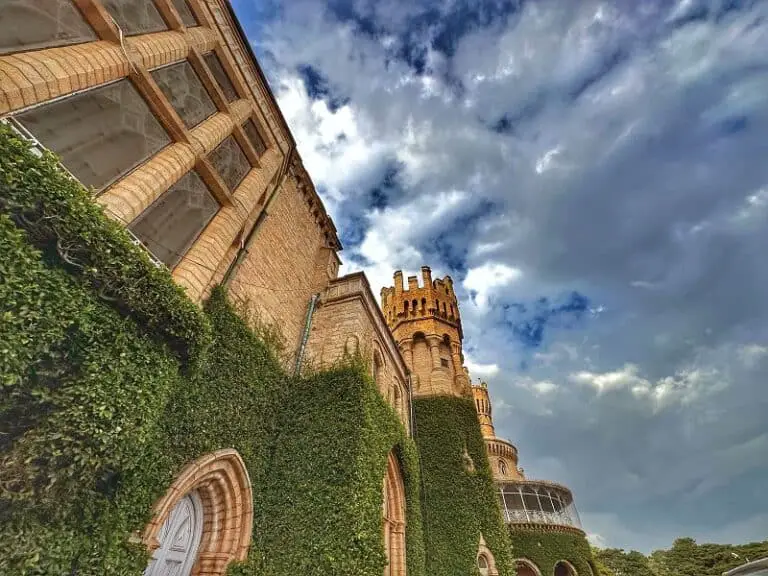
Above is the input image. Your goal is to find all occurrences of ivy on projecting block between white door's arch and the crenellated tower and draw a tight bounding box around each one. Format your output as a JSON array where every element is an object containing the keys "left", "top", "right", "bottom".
[{"left": 236, "top": 356, "right": 424, "bottom": 576}]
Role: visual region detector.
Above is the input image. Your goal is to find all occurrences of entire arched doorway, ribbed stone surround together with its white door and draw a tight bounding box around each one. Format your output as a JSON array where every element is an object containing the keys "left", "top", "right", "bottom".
[{"left": 142, "top": 449, "right": 253, "bottom": 576}]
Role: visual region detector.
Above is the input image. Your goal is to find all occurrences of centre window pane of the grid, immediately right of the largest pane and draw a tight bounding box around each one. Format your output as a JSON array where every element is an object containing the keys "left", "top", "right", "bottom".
[{"left": 152, "top": 61, "right": 216, "bottom": 128}]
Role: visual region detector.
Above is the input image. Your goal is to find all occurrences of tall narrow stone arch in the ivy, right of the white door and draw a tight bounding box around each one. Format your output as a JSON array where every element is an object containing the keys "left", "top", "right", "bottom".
[{"left": 382, "top": 450, "right": 405, "bottom": 576}]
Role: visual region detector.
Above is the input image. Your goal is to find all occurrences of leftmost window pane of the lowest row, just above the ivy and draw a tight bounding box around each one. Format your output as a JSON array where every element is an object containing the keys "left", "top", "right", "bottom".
[{"left": 131, "top": 171, "right": 219, "bottom": 268}]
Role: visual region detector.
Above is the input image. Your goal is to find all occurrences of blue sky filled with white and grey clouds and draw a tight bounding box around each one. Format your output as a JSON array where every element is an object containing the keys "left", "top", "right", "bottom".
[{"left": 232, "top": 0, "right": 768, "bottom": 552}]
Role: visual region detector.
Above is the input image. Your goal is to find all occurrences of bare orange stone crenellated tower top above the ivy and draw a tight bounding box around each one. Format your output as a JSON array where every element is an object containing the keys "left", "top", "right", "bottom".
[{"left": 381, "top": 266, "right": 471, "bottom": 398}]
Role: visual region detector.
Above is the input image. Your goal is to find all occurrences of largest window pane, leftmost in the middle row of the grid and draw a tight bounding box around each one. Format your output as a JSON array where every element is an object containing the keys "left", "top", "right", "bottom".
[{"left": 16, "top": 80, "right": 170, "bottom": 190}]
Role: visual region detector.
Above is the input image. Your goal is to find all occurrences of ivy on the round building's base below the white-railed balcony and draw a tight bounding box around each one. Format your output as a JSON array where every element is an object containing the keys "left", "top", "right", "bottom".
[{"left": 509, "top": 526, "right": 597, "bottom": 576}]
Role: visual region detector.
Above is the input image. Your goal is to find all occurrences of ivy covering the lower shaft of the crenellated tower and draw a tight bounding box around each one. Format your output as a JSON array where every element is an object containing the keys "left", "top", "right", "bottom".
[{"left": 414, "top": 397, "right": 514, "bottom": 576}]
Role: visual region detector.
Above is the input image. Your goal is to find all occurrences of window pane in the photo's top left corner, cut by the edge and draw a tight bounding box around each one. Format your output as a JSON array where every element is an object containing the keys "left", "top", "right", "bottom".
[{"left": 0, "top": 0, "right": 98, "bottom": 54}]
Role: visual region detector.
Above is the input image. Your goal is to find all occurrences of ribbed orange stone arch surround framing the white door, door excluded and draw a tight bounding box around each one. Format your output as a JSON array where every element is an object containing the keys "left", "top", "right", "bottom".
[{"left": 142, "top": 448, "right": 253, "bottom": 576}]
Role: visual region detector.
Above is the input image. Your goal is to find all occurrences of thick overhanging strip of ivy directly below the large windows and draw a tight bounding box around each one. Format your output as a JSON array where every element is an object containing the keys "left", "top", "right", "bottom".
[{"left": 0, "top": 123, "right": 210, "bottom": 360}]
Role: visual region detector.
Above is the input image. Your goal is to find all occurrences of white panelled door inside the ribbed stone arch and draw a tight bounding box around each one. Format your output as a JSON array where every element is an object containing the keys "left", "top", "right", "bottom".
[{"left": 144, "top": 492, "right": 203, "bottom": 576}]
